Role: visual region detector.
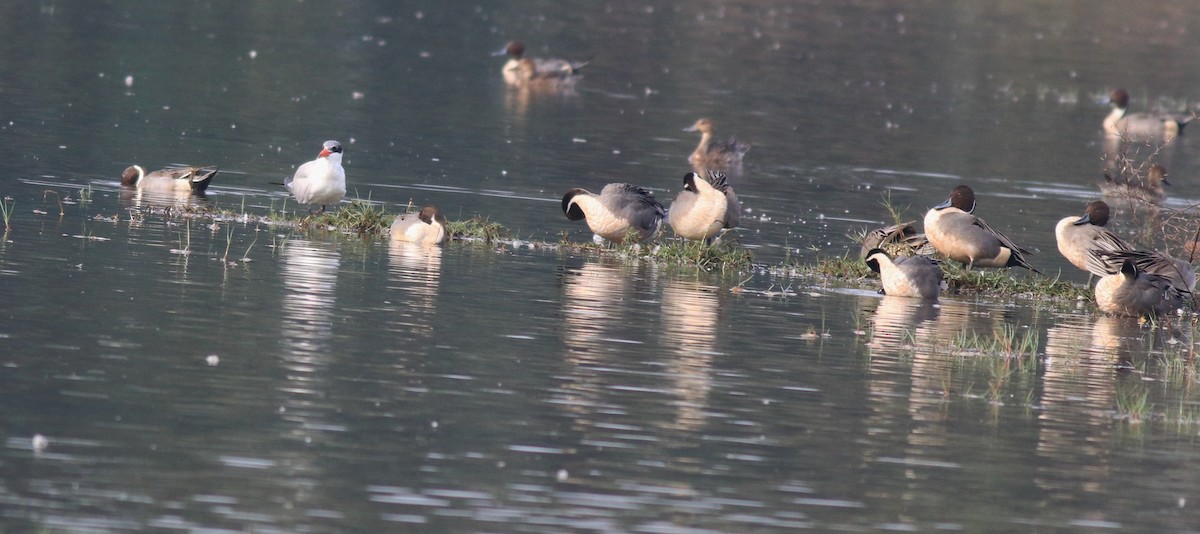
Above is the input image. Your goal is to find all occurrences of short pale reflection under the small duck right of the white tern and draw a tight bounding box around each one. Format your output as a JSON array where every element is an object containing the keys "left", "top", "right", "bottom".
[{"left": 388, "top": 240, "right": 442, "bottom": 338}]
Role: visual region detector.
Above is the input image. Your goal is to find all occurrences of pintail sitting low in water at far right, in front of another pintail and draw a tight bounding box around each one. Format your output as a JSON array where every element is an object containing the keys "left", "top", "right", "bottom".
[{"left": 1088, "top": 251, "right": 1183, "bottom": 317}]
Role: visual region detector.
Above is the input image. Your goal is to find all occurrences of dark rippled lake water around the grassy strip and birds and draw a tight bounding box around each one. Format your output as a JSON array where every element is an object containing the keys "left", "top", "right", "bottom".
[{"left": 0, "top": 1, "right": 1200, "bottom": 532}]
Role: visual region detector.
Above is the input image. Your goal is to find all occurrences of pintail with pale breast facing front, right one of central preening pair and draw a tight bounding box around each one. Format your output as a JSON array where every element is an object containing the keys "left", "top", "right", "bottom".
[{"left": 667, "top": 170, "right": 742, "bottom": 242}]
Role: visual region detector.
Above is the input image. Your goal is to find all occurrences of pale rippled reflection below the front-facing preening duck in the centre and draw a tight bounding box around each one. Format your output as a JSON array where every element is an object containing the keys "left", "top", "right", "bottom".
[{"left": 662, "top": 278, "right": 721, "bottom": 430}]
